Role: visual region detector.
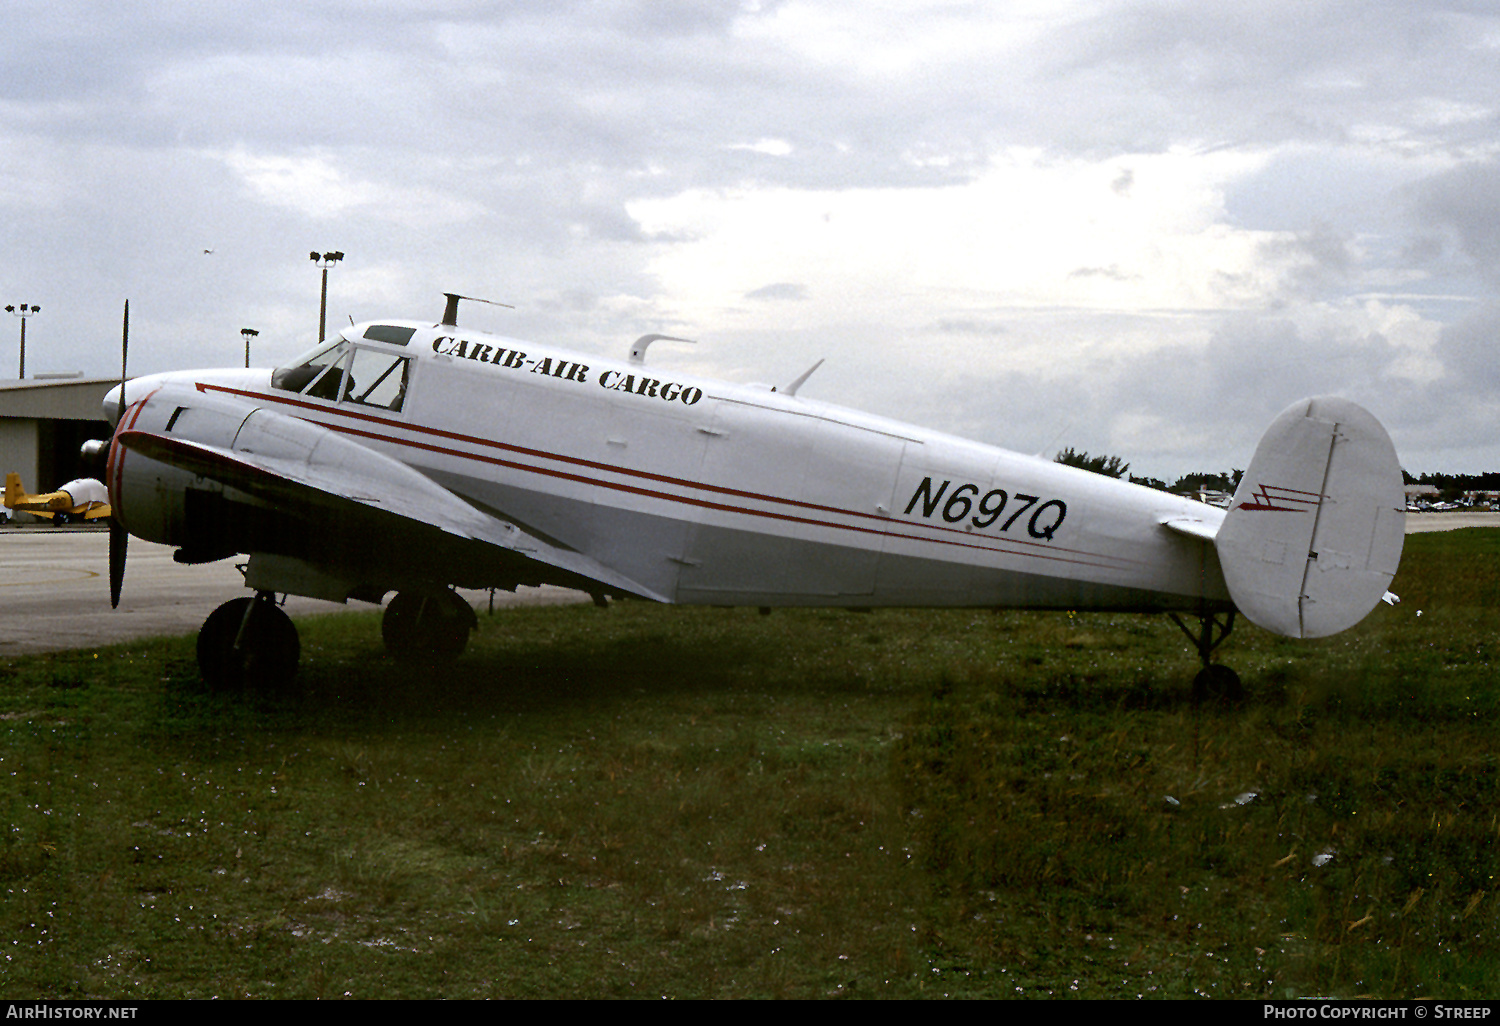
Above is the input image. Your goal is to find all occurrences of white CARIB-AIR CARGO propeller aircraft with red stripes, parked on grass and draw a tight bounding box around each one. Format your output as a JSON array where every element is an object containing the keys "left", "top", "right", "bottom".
[{"left": 93, "top": 296, "right": 1404, "bottom": 689}]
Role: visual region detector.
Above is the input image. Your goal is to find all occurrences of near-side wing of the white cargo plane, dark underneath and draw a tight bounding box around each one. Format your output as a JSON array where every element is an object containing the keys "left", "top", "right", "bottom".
[{"left": 116, "top": 410, "right": 666, "bottom": 602}]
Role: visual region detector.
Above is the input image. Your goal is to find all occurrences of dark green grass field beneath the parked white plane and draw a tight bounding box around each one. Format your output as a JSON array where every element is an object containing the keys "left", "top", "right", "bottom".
[{"left": 0, "top": 530, "right": 1500, "bottom": 999}]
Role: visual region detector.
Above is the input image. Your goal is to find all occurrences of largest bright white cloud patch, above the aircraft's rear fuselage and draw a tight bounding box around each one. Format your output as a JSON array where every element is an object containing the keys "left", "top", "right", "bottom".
[{"left": 629, "top": 142, "right": 1331, "bottom": 324}]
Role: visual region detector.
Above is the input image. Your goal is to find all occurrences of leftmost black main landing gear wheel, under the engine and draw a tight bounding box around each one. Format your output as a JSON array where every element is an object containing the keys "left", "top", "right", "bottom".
[{"left": 198, "top": 591, "right": 302, "bottom": 690}]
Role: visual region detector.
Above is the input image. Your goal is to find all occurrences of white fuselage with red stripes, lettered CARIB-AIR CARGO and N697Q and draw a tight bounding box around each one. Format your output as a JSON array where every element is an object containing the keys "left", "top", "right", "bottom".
[{"left": 114, "top": 321, "right": 1229, "bottom": 611}]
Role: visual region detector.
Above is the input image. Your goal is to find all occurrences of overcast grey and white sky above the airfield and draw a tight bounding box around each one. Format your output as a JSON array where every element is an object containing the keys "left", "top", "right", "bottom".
[{"left": 0, "top": 0, "right": 1500, "bottom": 480}]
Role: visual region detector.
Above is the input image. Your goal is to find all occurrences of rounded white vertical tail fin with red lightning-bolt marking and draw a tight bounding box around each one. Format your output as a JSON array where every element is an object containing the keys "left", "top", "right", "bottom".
[{"left": 1214, "top": 396, "right": 1406, "bottom": 638}]
